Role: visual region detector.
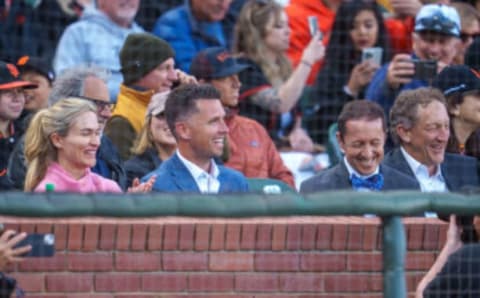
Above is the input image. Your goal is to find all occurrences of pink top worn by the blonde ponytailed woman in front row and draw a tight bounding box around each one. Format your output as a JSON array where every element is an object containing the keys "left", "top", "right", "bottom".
[{"left": 34, "top": 162, "right": 122, "bottom": 193}]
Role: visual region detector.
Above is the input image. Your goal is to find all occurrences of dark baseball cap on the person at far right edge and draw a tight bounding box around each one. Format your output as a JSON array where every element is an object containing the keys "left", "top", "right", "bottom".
[{"left": 432, "top": 65, "right": 480, "bottom": 96}]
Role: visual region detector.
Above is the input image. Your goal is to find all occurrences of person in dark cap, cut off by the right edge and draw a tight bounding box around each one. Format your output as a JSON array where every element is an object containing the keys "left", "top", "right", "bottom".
[{"left": 433, "top": 65, "right": 480, "bottom": 159}]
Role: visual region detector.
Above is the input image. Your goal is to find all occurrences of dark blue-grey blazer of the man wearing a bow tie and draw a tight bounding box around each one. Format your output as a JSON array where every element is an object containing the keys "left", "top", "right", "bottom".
[{"left": 300, "top": 160, "right": 418, "bottom": 193}]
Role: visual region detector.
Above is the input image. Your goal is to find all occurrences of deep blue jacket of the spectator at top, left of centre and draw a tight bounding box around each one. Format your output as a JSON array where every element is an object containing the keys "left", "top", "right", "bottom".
[{"left": 153, "top": 0, "right": 227, "bottom": 72}]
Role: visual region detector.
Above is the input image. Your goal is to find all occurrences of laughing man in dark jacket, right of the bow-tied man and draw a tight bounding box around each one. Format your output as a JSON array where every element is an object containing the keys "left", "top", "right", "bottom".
[{"left": 385, "top": 87, "right": 478, "bottom": 192}]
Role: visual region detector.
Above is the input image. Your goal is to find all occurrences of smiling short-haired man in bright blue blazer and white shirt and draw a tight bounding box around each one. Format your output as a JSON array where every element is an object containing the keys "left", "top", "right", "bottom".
[{"left": 142, "top": 84, "right": 248, "bottom": 193}]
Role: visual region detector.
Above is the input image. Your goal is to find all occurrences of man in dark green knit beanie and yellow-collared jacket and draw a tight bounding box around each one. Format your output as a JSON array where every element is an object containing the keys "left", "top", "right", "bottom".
[{"left": 105, "top": 33, "right": 196, "bottom": 160}]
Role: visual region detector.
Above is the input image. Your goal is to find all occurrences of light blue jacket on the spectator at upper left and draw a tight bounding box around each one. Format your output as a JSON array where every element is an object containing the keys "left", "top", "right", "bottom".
[{"left": 53, "top": 7, "right": 144, "bottom": 102}]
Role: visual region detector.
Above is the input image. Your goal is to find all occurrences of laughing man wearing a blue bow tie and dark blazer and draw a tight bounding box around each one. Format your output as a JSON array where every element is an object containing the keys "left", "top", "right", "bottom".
[{"left": 300, "top": 100, "right": 417, "bottom": 193}]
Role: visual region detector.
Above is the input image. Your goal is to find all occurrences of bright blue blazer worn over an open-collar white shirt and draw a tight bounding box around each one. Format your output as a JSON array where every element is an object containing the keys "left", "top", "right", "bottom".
[{"left": 141, "top": 154, "right": 248, "bottom": 193}]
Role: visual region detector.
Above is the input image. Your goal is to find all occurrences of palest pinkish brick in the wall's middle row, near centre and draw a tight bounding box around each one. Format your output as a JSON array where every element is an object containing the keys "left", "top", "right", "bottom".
[{"left": 209, "top": 252, "right": 253, "bottom": 271}]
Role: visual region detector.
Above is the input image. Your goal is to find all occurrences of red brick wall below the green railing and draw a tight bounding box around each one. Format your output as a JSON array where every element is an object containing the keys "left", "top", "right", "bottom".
[{"left": 0, "top": 217, "right": 446, "bottom": 298}]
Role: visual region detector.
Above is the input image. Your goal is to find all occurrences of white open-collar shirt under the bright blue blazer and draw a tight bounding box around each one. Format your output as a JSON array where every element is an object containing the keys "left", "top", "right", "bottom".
[{"left": 177, "top": 150, "right": 220, "bottom": 193}]
